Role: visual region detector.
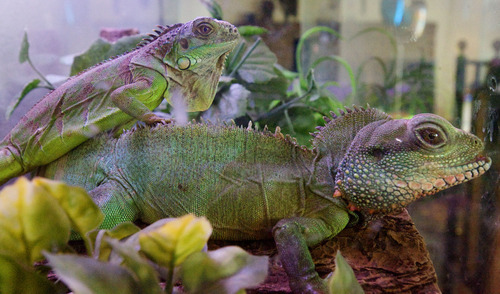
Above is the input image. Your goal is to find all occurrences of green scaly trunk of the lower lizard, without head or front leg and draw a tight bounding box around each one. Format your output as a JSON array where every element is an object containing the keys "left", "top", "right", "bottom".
[{"left": 39, "top": 124, "right": 338, "bottom": 240}]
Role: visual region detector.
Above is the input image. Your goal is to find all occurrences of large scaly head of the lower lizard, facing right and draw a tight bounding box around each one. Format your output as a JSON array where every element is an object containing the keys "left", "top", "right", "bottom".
[{"left": 313, "top": 109, "right": 491, "bottom": 213}]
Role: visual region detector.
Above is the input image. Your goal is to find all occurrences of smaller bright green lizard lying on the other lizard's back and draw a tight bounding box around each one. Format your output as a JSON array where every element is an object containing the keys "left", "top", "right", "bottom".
[{"left": 0, "top": 17, "right": 239, "bottom": 184}]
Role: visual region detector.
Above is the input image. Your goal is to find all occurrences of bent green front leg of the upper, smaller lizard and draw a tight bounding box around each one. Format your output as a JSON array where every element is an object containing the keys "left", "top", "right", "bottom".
[{"left": 110, "top": 71, "right": 170, "bottom": 124}]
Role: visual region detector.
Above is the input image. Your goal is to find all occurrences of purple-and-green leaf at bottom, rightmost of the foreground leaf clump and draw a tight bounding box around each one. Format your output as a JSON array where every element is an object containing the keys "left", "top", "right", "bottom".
[{"left": 181, "top": 246, "right": 268, "bottom": 293}]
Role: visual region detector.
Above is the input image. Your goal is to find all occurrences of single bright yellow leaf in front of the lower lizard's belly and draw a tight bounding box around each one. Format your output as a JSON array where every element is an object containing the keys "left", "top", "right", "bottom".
[{"left": 139, "top": 214, "right": 212, "bottom": 269}]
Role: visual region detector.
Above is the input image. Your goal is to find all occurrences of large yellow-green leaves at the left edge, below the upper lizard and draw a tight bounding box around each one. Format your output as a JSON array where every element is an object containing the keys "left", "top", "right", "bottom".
[{"left": 0, "top": 178, "right": 103, "bottom": 265}]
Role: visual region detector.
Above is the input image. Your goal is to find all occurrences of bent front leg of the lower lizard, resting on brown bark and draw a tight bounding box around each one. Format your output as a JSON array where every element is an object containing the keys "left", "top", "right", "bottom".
[{"left": 273, "top": 206, "right": 349, "bottom": 293}]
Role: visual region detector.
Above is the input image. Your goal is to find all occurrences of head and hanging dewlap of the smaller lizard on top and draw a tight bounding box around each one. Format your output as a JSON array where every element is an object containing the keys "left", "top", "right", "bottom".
[{"left": 162, "top": 17, "right": 240, "bottom": 111}]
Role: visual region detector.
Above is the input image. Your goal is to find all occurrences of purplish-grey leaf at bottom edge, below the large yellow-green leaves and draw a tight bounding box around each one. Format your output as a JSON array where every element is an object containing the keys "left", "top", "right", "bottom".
[{"left": 45, "top": 253, "right": 141, "bottom": 294}]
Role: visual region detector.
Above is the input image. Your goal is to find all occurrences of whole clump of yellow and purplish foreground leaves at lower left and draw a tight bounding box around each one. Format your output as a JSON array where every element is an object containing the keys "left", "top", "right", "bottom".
[{"left": 0, "top": 178, "right": 268, "bottom": 293}]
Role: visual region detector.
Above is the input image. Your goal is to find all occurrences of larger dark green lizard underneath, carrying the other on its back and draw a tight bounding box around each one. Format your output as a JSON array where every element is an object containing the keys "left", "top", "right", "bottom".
[{"left": 39, "top": 107, "right": 491, "bottom": 293}]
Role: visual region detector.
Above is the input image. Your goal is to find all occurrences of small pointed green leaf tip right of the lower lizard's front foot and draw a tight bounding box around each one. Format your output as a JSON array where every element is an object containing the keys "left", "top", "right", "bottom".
[{"left": 328, "top": 251, "right": 365, "bottom": 294}]
